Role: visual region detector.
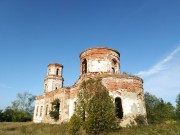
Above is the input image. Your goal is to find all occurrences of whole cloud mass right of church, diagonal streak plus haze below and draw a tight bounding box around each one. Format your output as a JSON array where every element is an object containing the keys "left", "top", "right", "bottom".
[{"left": 137, "top": 46, "right": 180, "bottom": 106}]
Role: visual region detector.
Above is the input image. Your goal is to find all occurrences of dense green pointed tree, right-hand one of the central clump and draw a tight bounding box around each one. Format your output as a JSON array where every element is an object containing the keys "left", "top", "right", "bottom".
[{"left": 85, "top": 80, "right": 116, "bottom": 134}]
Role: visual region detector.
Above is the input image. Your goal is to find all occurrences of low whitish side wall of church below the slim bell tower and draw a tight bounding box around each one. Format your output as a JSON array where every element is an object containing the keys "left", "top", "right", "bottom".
[{"left": 33, "top": 88, "right": 70, "bottom": 124}]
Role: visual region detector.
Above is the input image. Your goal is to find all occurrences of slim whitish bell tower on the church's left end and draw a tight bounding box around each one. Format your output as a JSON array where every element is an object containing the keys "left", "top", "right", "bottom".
[{"left": 44, "top": 63, "right": 64, "bottom": 93}]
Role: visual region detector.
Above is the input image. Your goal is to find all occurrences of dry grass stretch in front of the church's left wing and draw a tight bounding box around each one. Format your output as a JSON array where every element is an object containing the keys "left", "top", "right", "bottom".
[{"left": 0, "top": 122, "right": 66, "bottom": 135}]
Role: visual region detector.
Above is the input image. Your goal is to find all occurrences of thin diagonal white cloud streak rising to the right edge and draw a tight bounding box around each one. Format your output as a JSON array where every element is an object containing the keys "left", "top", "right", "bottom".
[{"left": 136, "top": 46, "right": 180, "bottom": 78}]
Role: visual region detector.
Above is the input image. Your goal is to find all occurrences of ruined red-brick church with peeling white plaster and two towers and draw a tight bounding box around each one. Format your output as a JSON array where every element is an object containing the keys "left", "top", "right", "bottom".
[{"left": 33, "top": 47, "right": 146, "bottom": 127}]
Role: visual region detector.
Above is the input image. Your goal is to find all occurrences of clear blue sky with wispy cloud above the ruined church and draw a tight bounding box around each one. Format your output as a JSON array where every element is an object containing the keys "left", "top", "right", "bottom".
[{"left": 0, "top": 0, "right": 180, "bottom": 109}]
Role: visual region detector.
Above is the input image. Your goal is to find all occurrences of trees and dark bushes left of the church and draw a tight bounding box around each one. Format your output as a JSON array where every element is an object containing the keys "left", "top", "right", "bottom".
[{"left": 0, "top": 92, "right": 35, "bottom": 122}]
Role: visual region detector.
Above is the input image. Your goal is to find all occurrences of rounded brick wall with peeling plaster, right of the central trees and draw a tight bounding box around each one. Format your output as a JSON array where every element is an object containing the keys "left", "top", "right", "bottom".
[{"left": 102, "top": 76, "right": 146, "bottom": 126}]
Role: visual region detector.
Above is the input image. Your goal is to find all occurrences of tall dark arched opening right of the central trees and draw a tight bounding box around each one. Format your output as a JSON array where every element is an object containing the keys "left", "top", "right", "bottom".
[{"left": 115, "top": 97, "right": 123, "bottom": 119}]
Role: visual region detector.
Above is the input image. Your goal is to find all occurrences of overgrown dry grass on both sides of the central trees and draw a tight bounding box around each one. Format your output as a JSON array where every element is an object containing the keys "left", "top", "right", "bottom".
[{"left": 0, "top": 122, "right": 180, "bottom": 135}]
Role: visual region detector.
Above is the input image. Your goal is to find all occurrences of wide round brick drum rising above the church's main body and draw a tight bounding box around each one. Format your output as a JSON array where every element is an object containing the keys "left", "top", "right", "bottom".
[{"left": 80, "top": 47, "right": 120, "bottom": 75}]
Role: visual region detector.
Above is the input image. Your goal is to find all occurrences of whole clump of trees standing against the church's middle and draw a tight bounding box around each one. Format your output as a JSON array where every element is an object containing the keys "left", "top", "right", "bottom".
[{"left": 76, "top": 79, "right": 116, "bottom": 134}]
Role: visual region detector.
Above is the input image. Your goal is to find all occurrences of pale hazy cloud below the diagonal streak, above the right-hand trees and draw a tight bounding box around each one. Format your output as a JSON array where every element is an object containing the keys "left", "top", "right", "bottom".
[{"left": 144, "top": 63, "right": 180, "bottom": 105}]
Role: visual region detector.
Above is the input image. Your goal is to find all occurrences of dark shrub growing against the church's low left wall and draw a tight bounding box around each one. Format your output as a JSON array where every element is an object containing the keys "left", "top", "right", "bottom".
[{"left": 49, "top": 99, "right": 60, "bottom": 120}]
